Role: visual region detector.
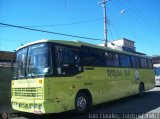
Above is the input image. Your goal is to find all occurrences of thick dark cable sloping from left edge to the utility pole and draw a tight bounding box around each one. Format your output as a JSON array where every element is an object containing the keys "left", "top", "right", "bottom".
[{"left": 0, "top": 23, "right": 104, "bottom": 41}]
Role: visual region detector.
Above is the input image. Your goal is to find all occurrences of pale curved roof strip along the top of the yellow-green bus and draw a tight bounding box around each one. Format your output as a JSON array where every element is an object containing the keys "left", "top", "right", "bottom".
[{"left": 16, "top": 39, "right": 152, "bottom": 59}]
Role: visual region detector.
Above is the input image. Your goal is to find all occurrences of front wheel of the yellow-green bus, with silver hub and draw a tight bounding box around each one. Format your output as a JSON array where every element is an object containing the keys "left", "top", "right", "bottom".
[{"left": 75, "top": 92, "right": 90, "bottom": 113}]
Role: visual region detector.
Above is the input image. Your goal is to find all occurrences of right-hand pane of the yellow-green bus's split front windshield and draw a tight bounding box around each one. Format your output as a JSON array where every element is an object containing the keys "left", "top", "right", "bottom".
[{"left": 27, "top": 43, "right": 52, "bottom": 77}]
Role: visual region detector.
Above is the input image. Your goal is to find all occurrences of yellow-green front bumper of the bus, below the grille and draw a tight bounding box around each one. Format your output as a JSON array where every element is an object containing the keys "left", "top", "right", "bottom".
[{"left": 11, "top": 98, "right": 56, "bottom": 114}]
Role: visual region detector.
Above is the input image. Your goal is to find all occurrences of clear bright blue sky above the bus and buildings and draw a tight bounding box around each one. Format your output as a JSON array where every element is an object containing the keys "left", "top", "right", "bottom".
[{"left": 0, "top": 0, "right": 160, "bottom": 56}]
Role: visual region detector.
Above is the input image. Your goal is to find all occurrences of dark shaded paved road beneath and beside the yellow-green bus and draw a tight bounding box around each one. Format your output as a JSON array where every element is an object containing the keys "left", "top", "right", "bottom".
[{"left": 1, "top": 87, "right": 160, "bottom": 119}]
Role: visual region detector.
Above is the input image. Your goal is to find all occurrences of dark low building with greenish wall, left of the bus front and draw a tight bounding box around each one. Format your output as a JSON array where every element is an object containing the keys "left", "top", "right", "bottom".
[{"left": 0, "top": 51, "right": 16, "bottom": 107}]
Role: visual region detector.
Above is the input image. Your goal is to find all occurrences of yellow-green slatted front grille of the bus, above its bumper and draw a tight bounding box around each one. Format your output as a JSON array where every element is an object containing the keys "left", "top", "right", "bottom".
[{"left": 12, "top": 87, "right": 42, "bottom": 98}]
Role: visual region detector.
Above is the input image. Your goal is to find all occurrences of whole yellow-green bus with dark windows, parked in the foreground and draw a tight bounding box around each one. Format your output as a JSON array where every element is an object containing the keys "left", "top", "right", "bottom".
[{"left": 11, "top": 40, "right": 155, "bottom": 114}]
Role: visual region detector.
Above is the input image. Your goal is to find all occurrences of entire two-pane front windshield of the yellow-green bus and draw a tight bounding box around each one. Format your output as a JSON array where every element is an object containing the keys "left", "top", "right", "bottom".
[{"left": 15, "top": 43, "right": 52, "bottom": 78}]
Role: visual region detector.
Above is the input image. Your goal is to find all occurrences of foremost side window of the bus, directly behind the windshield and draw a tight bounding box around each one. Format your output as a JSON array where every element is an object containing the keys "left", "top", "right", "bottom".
[{"left": 56, "top": 46, "right": 82, "bottom": 76}]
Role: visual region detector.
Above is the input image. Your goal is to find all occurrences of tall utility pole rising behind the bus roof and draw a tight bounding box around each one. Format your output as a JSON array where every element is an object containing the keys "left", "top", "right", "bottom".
[{"left": 98, "top": 0, "right": 108, "bottom": 47}]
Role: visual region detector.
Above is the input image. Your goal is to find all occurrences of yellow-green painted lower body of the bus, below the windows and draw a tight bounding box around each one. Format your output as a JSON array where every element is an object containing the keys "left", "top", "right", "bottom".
[{"left": 11, "top": 67, "right": 154, "bottom": 113}]
